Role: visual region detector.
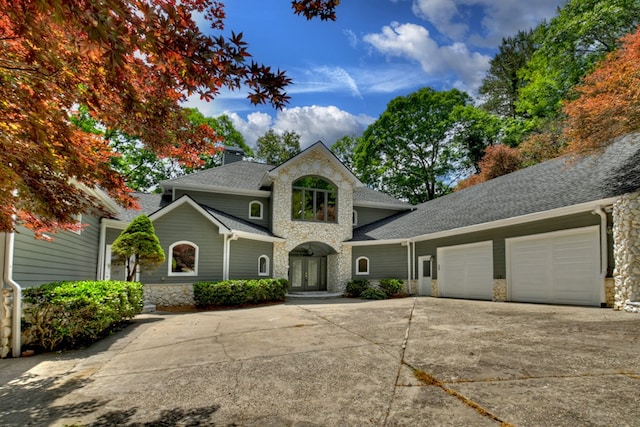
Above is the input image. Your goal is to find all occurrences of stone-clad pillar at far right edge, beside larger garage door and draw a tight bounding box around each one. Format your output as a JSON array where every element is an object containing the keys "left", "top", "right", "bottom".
[{"left": 613, "top": 192, "right": 640, "bottom": 311}]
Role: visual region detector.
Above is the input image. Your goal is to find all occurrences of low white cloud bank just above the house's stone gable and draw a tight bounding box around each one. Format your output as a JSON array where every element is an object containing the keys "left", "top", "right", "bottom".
[{"left": 227, "top": 105, "right": 374, "bottom": 149}]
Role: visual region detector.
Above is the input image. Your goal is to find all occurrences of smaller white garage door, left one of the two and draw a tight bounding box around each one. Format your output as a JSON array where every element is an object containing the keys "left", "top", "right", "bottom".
[{"left": 438, "top": 241, "right": 493, "bottom": 300}]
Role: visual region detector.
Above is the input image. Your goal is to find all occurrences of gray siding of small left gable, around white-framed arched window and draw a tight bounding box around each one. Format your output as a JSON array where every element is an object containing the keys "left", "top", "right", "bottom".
[{"left": 140, "top": 204, "right": 224, "bottom": 283}]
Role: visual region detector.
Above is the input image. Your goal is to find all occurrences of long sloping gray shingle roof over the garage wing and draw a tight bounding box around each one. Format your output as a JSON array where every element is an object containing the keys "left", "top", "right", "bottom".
[{"left": 353, "top": 133, "right": 640, "bottom": 241}]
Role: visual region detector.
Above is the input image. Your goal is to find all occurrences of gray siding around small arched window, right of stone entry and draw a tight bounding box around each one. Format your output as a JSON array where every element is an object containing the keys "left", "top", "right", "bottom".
[{"left": 351, "top": 243, "right": 408, "bottom": 280}]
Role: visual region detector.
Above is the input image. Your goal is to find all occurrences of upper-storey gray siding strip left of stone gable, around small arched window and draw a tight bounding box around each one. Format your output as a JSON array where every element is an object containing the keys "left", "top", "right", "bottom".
[{"left": 176, "top": 190, "right": 271, "bottom": 228}]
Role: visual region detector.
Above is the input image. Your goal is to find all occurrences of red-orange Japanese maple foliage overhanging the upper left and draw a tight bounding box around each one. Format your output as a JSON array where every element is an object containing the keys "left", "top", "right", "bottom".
[{"left": 0, "top": 0, "right": 338, "bottom": 232}]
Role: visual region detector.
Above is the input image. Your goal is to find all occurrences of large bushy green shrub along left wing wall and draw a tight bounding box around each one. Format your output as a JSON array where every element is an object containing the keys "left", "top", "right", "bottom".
[{"left": 22, "top": 281, "right": 143, "bottom": 351}]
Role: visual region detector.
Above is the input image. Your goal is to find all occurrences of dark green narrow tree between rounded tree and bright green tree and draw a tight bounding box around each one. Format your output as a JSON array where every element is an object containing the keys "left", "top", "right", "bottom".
[{"left": 478, "top": 30, "right": 535, "bottom": 119}]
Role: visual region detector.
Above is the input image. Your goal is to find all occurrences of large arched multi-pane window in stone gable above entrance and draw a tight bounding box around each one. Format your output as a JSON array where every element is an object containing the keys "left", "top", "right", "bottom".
[{"left": 291, "top": 176, "right": 338, "bottom": 222}]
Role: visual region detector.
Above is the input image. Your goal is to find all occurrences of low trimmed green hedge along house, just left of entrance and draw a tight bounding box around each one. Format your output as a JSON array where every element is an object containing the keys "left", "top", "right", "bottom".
[{"left": 193, "top": 279, "right": 289, "bottom": 308}]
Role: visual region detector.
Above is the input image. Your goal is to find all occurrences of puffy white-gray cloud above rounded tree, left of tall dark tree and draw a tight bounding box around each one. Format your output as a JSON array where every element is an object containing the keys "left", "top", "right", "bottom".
[{"left": 364, "top": 22, "right": 491, "bottom": 94}]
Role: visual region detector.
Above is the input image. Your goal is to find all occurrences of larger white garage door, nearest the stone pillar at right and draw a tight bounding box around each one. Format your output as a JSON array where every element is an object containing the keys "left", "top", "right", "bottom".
[{"left": 506, "top": 226, "right": 602, "bottom": 306}]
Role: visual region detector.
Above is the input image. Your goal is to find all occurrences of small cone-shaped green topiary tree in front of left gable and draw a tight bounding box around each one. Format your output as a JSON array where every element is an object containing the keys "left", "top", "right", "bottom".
[{"left": 111, "top": 215, "right": 165, "bottom": 282}]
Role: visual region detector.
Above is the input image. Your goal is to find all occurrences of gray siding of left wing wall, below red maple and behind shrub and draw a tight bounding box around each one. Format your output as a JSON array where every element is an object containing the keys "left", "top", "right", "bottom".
[{"left": 13, "top": 215, "right": 100, "bottom": 287}]
